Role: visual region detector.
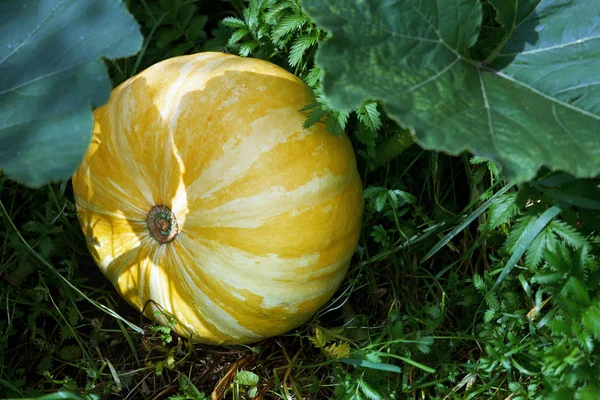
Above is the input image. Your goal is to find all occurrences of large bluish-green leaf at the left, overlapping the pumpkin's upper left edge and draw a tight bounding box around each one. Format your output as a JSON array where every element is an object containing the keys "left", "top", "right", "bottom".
[{"left": 0, "top": 0, "right": 143, "bottom": 187}]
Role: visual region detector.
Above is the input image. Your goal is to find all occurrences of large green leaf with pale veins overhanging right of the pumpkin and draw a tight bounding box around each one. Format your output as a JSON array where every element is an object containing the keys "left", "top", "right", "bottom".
[{"left": 303, "top": 0, "right": 600, "bottom": 181}]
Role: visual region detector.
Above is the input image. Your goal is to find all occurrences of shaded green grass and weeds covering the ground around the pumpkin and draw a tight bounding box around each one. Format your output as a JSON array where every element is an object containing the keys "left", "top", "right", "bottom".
[{"left": 0, "top": 0, "right": 600, "bottom": 399}]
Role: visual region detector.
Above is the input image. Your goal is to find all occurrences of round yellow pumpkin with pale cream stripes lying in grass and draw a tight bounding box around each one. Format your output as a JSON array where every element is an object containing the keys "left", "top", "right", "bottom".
[{"left": 73, "top": 53, "right": 363, "bottom": 344}]
